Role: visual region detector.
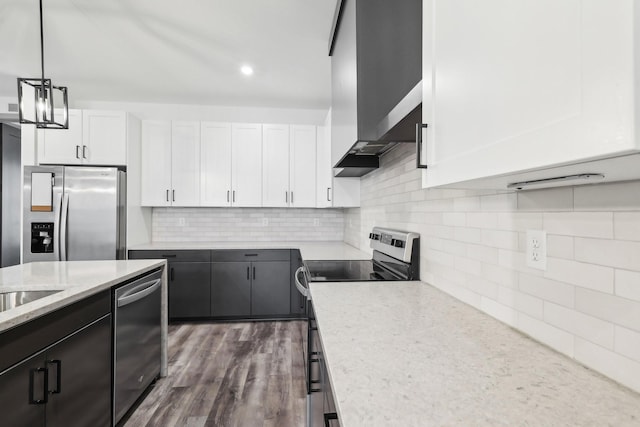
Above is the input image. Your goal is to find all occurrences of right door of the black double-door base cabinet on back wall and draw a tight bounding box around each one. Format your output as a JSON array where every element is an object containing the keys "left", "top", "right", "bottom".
[{"left": 251, "top": 261, "right": 291, "bottom": 316}]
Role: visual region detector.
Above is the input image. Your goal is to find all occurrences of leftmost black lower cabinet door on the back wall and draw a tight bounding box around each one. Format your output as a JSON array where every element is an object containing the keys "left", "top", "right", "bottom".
[{"left": 169, "top": 262, "right": 211, "bottom": 319}]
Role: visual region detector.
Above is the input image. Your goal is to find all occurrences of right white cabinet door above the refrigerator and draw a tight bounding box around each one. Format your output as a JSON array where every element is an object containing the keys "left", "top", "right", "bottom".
[{"left": 82, "top": 110, "right": 127, "bottom": 166}]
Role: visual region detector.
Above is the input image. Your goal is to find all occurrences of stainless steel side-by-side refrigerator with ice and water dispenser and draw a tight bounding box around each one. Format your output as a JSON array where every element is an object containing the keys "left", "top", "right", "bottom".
[{"left": 22, "top": 166, "right": 126, "bottom": 262}]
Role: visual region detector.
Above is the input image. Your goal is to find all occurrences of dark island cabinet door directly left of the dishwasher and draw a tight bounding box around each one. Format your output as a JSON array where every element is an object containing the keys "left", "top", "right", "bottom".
[{"left": 45, "top": 314, "right": 111, "bottom": 427}]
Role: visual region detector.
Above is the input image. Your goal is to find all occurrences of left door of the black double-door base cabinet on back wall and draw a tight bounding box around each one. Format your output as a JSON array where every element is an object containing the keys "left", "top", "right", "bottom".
[{"left": 211, "top": 262, "right": 253, "bottom": 317}]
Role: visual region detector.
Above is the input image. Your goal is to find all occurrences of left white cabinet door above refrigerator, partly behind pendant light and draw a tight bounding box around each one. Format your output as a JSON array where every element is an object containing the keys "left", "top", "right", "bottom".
[{"left": 38, "top": 110, "right": 83, "bottom": 165}]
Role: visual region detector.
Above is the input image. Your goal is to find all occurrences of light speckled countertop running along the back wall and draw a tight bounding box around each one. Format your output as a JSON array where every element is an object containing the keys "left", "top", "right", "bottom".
[{"left": 129, "top": 241, "right": 371, "bottom": 261}]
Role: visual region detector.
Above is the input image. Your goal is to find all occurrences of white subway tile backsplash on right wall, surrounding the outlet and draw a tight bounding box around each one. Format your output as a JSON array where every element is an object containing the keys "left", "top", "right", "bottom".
[{"left": 345, "top": 145, "right": 640, "bottom": 391}]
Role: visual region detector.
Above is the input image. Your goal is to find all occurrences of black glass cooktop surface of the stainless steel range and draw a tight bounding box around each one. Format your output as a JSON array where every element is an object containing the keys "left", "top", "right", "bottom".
[{"left": 305, "top": 260, "right": 402, "bottom": 282}]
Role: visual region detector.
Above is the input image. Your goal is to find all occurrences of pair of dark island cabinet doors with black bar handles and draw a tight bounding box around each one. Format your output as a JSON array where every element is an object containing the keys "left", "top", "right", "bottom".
[{"left": 0, "top": 314, "right": 111, "bottom": 427}]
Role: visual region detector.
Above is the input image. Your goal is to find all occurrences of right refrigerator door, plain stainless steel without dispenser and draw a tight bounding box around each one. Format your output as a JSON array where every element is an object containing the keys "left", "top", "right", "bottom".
[{"left": 60, "top": 167, "right": 124, "bottom": 261}]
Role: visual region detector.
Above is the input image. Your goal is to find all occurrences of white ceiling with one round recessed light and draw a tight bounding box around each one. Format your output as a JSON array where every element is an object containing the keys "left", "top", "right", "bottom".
[{"left": 0, "top": 0, "right": 336, "bottom": 109}]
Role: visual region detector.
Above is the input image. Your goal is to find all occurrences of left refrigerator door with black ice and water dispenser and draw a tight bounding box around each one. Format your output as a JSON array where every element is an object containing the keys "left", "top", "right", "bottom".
[{"left": 22, "top": 166, "right": 64, "bottom": 263}]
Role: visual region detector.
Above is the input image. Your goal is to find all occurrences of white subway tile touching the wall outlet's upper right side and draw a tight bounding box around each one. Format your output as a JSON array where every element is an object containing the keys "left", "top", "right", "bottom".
[{"left": 543, "top": 212, "right": 613, "bottom": 239}]
